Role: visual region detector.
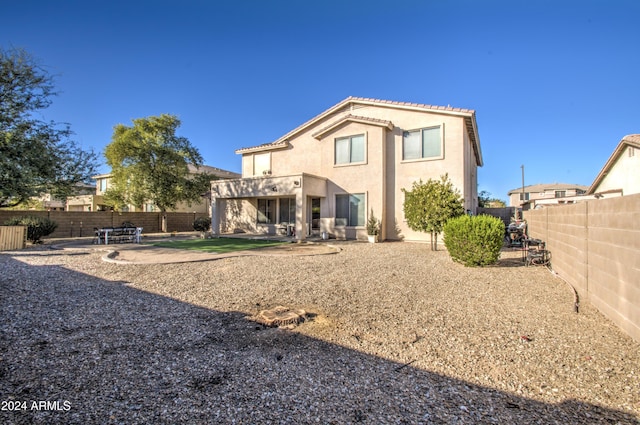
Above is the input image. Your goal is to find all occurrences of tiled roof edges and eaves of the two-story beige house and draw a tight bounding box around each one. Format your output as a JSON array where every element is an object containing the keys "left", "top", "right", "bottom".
[{"left": 236, "top": 96, "right": 483, "bottom": 166}]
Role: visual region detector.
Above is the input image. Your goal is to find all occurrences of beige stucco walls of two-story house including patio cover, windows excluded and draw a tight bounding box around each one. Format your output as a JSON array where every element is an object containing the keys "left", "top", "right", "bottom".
[{"left": 218, "top": 104, "right": 477, "bottom": 240}]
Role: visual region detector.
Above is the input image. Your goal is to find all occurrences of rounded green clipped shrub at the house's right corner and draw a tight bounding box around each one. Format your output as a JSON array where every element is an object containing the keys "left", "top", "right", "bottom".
[{"left": 444, "top": 215, "right": 504, "bottom": 266}]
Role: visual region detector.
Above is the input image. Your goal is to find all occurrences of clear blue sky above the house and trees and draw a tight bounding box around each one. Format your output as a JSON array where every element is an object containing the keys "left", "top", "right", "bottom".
[{"left": 0, "top": 0, "right": 640, "bottom": 200}]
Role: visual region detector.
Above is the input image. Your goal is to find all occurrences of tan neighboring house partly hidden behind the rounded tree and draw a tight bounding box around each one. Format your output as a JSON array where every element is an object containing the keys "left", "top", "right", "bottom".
[{"left": 67, "top": 165, "right": 240, "bottom": 213}]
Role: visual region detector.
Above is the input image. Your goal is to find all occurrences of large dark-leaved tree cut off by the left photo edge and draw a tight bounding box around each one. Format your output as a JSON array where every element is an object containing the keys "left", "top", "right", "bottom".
[{"left": 0, "top": 49, "right": 97, "bottom": 207}]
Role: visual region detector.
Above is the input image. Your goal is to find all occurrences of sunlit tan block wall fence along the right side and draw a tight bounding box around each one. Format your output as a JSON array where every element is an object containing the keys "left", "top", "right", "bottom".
[{"left": 524, "top": 194, "right": 640, "bottom": 341}]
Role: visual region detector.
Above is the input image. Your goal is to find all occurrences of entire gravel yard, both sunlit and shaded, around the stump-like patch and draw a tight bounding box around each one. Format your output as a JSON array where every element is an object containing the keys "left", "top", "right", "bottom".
[{"left": 0, "top": 242, "right": 640, "bottom": 424}]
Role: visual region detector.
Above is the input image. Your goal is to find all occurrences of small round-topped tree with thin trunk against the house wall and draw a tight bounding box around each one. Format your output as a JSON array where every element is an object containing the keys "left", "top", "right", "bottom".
[{"left": 402, "top": 174, "right": 464, "bottom": 251}]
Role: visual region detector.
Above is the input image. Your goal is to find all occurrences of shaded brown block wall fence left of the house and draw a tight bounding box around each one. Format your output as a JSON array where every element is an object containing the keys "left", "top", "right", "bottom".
[{"left": 0, "top": 211, "right": 209, "bottom": 239}]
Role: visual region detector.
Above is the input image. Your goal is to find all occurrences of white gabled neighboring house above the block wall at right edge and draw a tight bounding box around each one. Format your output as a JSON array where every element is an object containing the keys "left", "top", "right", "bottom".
[{"left": 587, "top": 134, "right": 640, "bottom": 197}]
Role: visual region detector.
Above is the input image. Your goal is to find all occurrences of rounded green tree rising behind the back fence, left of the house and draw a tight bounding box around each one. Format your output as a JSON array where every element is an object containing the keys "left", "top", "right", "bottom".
[{"left": 105, "top": 114, "right": 214, "bottom": 212}]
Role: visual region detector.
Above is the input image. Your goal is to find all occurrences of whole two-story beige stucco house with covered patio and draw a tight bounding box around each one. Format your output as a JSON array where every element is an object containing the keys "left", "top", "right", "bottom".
[{"left": 211, "top": 97, "right": 482, "bottom": 240}]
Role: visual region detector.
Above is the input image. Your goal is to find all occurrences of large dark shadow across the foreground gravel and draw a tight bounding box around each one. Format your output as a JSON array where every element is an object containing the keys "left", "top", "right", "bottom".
[{"left": 0, "top": 255, "right": 637, "bottom": 424}]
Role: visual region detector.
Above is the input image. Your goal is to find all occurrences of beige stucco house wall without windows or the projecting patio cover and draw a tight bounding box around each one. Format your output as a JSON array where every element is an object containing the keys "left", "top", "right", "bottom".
[{"left": 234, "top": 105, "right": 477, "bottom": 240}]
